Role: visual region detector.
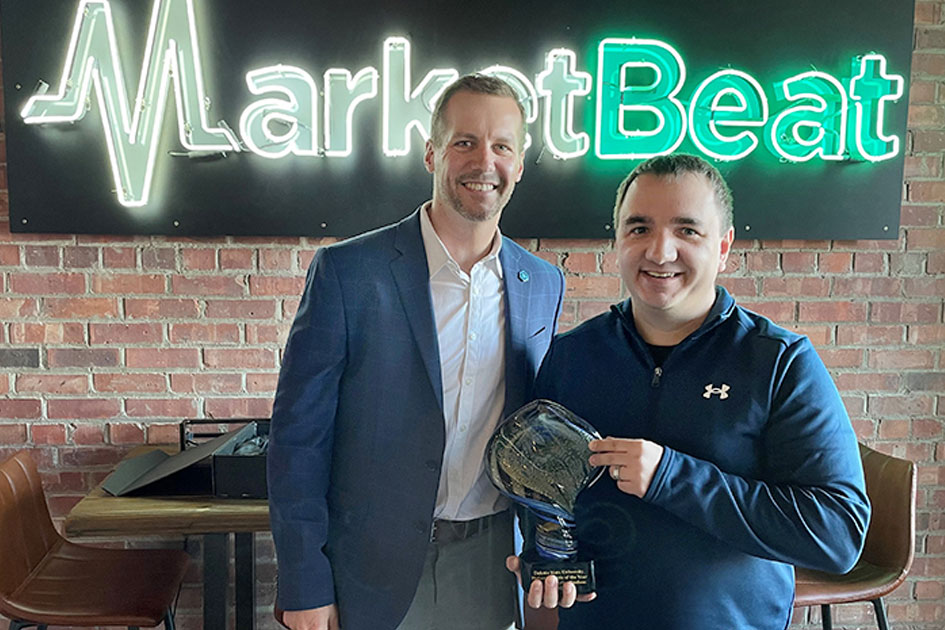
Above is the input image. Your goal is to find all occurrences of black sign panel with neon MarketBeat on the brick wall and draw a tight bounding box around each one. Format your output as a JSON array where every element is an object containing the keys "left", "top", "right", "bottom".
[{"left": 0, "top": 0, "right": 914, "bottom": 239}]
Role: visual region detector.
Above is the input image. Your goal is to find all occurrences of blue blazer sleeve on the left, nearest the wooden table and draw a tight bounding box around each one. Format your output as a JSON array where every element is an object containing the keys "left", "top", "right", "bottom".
[{"left": 267, "top": 248, "right": 347, "bottom": 610}]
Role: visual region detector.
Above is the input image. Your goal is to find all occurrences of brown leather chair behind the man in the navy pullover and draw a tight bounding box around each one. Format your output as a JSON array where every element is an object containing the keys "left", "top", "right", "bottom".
[{"left": 794, "top": 444, "right": 916, "bottom": 630}]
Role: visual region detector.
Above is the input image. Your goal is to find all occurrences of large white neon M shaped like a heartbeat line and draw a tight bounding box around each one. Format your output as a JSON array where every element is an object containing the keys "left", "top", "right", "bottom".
[{"left": 21, "top": 0, "right": 239, "bottom": 207}]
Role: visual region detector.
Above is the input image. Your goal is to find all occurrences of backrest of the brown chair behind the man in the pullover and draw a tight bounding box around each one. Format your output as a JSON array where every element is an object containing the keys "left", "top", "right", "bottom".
[{"left": 860, "top": 444, "right": 916, "bottom": 579}]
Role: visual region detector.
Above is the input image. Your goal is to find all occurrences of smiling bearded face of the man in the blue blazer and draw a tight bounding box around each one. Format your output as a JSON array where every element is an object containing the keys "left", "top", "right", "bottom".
[{"left": 423, "top": 92, "right": 523, "bottom": 222}]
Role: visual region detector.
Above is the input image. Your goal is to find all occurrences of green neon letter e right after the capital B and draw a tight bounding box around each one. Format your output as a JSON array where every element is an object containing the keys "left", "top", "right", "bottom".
[{"left": 689, "top": 70, "right": 768, "bottom": 161}]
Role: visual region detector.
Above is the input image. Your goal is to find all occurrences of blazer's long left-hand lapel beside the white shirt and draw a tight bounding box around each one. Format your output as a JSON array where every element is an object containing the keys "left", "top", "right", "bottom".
[{"left": 390, "top": 211, "right": 443, "bottom": 411}]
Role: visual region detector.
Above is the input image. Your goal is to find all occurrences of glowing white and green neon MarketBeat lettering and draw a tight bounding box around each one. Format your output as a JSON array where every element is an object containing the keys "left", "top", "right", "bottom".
[{"left": 21, "top": 0, "right": 904, "bottom": 207}]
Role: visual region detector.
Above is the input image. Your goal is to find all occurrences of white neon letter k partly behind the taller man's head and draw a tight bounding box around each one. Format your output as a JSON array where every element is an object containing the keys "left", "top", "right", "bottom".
[{"left": 382, "top": 37, "right": 459, "bottom": 157}]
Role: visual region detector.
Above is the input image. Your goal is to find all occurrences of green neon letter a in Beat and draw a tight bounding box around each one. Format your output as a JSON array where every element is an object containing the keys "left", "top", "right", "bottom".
[{"left": 767, "top": 71, "right": 847, "bottom": 162}]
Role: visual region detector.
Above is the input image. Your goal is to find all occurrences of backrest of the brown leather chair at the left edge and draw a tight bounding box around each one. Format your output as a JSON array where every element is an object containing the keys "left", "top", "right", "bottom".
[{"left": 0, "top": 451, "right": 60, "bottom": 599}]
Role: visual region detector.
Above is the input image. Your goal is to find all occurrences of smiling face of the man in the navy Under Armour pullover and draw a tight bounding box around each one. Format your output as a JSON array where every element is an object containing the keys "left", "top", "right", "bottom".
[{"left": 617, "top": 173, "right": 735, "bottom": 340}]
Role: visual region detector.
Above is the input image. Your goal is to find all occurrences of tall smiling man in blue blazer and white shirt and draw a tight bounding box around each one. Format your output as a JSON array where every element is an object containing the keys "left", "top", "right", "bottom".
[{"left": 268, "top": 75, "right": 564, "bottom": 630}]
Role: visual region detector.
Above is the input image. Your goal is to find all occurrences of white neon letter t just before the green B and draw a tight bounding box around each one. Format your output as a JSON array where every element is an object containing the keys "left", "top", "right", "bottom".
[{"left": 536, "top": 48, "right": 591, "bottom": 160}]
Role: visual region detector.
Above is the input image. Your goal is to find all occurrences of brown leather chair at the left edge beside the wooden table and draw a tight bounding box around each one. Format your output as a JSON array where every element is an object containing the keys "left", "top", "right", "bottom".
[{"left": 0, "top": 452, "right": 188, "bottom": 630}]
